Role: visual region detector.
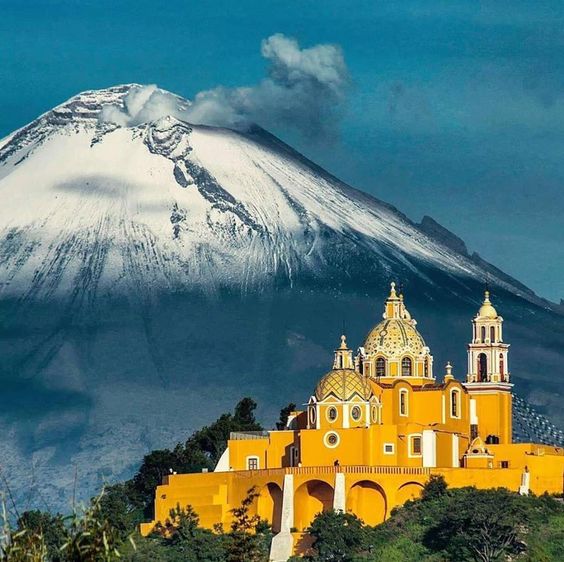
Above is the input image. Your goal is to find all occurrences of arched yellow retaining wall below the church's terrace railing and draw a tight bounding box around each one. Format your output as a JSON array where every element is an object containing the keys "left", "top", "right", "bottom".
[{"left": 142, "top": 456, "right": 564, "bottom": 534}]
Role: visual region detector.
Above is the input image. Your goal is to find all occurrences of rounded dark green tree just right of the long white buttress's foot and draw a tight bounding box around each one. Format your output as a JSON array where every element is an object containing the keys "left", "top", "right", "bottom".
[{"left": 308, "top": 511, "right": 368, "bottom": 562}]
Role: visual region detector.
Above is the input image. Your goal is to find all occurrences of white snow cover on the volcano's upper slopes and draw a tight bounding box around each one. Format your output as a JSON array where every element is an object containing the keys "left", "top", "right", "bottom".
[{"left": 0, "top": 86, "right": 516, "bottom": 302}]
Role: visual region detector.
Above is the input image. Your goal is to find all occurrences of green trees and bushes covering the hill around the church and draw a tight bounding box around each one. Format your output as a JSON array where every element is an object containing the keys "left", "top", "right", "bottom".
[{"left": 0, "top": 398, "right": 564, "bottom": 562}]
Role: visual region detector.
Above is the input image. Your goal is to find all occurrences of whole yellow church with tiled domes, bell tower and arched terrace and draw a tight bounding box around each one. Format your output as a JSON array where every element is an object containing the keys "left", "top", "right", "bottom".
[{"left": 141, "top": 283, "right": 564, "bottom": 561}]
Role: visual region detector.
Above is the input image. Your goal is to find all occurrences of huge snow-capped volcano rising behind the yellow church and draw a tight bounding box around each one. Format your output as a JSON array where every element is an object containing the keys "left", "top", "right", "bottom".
[{"left": 0, "top": 86, "right": 564, "bottom": 505}]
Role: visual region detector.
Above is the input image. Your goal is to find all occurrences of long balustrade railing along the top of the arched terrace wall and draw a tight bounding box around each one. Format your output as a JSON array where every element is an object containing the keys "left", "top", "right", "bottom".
[{"left": 232, "top": 465, "right": 431, "bottom": 478}]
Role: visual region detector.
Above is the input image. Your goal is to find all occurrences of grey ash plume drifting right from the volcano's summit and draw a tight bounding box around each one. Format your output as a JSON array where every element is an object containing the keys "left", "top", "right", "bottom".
[{"left": 100, "top": 33, "right": 349, "bottom": 137}]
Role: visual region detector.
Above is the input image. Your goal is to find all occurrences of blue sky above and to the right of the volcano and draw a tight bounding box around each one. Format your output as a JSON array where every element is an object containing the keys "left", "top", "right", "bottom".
[{"left": 0, "top": 0, "right": 564, "bottom": 300}]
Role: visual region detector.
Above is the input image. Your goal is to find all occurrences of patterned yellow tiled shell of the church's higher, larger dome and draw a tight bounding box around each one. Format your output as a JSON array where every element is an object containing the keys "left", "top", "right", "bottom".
[{"left": 364, "top": 318, "right": 426, "bottom": 357}]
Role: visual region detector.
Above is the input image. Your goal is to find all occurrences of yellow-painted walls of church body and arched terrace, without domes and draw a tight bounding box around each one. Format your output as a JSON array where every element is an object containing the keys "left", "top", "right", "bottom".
[{"left": 141, "top": 378, "right": 564, "bottom": 551}]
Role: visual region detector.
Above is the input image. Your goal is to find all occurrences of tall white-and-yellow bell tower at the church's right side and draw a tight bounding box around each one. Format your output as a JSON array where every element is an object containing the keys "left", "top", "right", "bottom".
[{"left": 464, "top": 291, "right": 513, "bottom": 444}]
